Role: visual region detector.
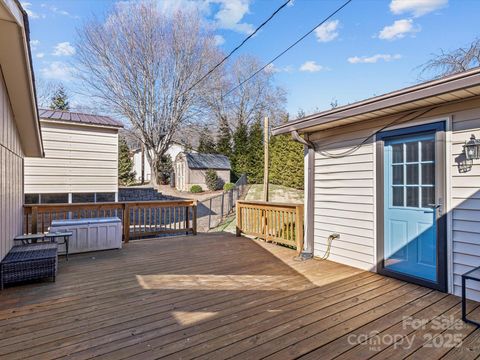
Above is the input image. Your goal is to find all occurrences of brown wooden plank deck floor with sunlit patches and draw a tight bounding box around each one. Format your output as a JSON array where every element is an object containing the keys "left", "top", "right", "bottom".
[{"left": 0, "top": 234, "right": 480, "bottom": 360}]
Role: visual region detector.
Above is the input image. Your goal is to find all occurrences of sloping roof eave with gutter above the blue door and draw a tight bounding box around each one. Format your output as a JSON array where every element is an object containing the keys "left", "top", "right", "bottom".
[{"left": 272, "top": 67, "right": 480, "bottom": 135}]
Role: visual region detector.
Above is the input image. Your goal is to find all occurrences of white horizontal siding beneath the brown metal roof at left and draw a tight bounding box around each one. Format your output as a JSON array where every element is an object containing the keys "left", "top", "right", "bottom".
[{"left": 25, "top": 121, "right": 118, "bottom": 194}]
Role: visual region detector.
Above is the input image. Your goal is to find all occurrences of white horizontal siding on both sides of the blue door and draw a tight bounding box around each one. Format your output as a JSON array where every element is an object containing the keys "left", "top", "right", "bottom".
[{"left": 310, "top": 99, "right": 480, "bottom": 300}]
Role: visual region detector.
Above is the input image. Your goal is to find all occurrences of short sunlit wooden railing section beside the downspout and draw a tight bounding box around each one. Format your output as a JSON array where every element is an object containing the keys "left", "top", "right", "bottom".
[{"left": 237, "top": 200, "right": 303, "bottom": 254}]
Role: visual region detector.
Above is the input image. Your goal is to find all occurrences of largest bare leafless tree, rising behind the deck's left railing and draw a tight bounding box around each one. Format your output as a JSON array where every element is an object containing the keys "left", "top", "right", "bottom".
[{"left": 77, "top": 1, "right": 219, "bottom": 183}]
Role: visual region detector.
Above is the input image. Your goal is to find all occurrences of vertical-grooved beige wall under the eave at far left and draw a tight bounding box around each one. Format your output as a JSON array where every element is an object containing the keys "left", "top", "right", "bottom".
[{"left": 0, "top": 71, "right": 23, "bottom": 260}]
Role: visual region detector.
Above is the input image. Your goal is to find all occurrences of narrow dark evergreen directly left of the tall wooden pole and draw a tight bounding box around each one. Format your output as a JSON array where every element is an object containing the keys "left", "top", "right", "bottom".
[{"left": 247, "top": 121, "right": 264, "bottom": 184}]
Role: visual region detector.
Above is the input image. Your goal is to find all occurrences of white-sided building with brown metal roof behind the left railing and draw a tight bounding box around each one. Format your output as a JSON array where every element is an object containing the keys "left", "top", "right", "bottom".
[{"left": 25, "top": 110, "right": 123, "bottom": 204}]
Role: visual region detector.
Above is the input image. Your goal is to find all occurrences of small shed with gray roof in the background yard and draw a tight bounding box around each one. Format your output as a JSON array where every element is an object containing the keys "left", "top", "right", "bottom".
[{"left": 175, "top": 152, "right": 231, "bottom": 191}]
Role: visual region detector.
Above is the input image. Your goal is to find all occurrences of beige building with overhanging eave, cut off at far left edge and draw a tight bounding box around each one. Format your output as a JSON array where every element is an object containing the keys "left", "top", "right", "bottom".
[{"left": 0, "top": 0, "right": 43, "bottom": 260}]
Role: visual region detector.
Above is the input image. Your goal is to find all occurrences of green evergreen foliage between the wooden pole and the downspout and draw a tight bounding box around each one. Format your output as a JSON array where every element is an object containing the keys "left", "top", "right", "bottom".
[{"left": 269, "top": 135, "right": 304, "bottom": 189}]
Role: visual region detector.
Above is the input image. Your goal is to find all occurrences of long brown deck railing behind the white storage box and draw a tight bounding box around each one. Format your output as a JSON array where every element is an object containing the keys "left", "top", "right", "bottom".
[{"left": 24, "top": 200, "right": 197, "bottom": 242}]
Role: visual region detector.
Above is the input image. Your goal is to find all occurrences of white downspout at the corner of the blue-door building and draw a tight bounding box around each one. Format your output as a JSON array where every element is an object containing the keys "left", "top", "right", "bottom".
[{"left": 290, "top": 130, "right": 315, "bottom": 260}]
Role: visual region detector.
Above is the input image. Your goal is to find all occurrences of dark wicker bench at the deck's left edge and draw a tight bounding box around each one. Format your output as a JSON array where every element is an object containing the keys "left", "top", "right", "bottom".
[{"left": 0, "top": 243, "right": 58, "bottom": 290}]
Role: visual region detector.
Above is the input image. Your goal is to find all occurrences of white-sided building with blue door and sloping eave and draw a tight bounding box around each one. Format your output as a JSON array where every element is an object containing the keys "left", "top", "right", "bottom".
[{"left": 273, "top": 68, "right": 480, "bottom": 300}]
